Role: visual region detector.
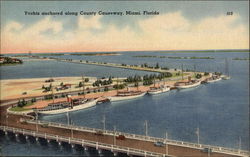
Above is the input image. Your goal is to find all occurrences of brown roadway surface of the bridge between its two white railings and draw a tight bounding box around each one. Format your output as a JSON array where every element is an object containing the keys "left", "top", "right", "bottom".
[{"left": 0, "top": 103, "right": 247, "bottom": 157}]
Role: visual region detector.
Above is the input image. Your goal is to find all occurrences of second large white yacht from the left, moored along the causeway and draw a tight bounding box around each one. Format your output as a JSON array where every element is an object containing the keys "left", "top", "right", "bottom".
[{"left": 108, "top": 91, "right": 146, "bottom": 102}]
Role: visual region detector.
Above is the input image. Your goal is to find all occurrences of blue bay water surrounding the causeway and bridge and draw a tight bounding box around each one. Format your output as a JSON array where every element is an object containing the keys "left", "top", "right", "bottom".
[{"left": 1, "top": 52, "right": 249, "bottom": 155}]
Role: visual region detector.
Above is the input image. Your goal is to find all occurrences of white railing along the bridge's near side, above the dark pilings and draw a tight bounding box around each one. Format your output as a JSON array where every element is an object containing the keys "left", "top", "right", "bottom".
[{"left": 0, "top": 126, "right": 165, "bottom": 156}]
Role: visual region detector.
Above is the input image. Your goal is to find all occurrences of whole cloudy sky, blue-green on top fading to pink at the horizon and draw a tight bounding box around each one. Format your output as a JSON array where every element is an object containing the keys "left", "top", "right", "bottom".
[{"left": 0, "top": 1, "right": 249, "bottom": 54}]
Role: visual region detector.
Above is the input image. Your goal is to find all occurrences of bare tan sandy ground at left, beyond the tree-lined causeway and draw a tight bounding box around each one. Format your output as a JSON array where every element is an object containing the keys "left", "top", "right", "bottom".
[{"left": 0, "top": 77, "right": 96, "bottom": 100}]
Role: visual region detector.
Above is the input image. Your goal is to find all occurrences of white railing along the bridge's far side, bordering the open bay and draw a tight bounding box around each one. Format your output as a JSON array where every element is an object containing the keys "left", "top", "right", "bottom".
[{"left": 28, "top": 120, "right": 249, "bottom": 155}]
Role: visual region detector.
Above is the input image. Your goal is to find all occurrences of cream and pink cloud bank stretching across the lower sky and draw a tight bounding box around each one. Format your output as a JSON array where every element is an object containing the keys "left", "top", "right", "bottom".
[{"left": 1, "top": 12, "right": 249, "bottom": 53}]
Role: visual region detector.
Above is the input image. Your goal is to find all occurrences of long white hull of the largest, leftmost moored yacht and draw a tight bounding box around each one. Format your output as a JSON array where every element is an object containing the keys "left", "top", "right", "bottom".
[{"left": 38, "top": 99, "right": 97, "bottom": 115}]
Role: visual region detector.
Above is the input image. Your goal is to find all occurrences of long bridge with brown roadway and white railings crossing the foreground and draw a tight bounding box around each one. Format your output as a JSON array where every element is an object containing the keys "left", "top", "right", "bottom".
[{"left": 0, "top": 103, "right": 249, "bottom": 157}]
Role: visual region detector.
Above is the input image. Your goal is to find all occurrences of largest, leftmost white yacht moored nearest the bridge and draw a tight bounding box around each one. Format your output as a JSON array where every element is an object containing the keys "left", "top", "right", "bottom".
[{"left": 35, "top": 99, "right": 97, "bottom": 115}]
